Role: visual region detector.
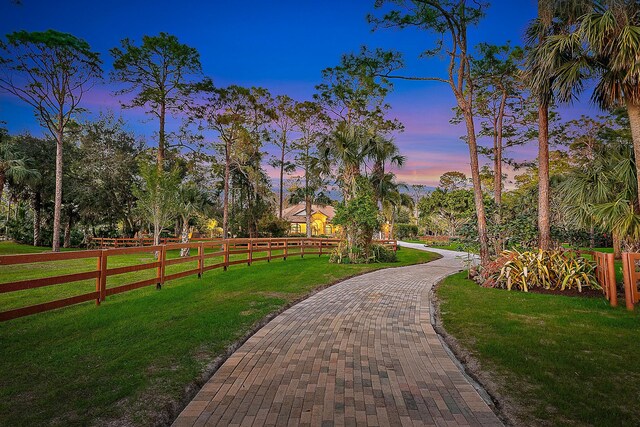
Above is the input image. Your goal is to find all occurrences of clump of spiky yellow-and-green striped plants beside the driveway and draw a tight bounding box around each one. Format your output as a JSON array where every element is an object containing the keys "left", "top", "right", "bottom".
[{"left": 481, "top": 250, "right": 602, "bottom": 292}]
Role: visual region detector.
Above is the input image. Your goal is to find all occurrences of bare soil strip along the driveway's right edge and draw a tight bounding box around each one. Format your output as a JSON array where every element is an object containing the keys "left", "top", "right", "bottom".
[{"left": 429, "top": 270, "right": 521, "bottom": 426}]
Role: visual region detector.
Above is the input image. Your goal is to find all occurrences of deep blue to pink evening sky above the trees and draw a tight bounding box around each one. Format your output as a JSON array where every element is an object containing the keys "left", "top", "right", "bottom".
[{"left": 0, "top": 0, "right": 597, "bottom": 185}]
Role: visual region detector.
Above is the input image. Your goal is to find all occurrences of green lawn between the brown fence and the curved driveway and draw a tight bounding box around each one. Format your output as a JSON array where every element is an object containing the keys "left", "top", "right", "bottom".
[{"left": 0, "top": 242, "right": 437, "bottom": 426}]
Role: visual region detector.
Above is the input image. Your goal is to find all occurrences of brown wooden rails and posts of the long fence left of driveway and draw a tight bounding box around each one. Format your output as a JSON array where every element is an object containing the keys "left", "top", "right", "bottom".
[{"left": 0, "top": 238, "right": 397, "bottom": 321}]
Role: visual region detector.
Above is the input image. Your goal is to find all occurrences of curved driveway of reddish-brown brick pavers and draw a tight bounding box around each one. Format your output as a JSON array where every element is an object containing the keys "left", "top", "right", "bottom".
[{"left": 174, "top": 244, "right": 501, "bottom": 426}]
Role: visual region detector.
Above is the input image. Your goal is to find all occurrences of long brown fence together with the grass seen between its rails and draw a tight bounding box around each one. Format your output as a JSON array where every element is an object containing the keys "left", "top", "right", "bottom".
[{"left": 0, "top": 238, "right": 397, "bottom": 321}]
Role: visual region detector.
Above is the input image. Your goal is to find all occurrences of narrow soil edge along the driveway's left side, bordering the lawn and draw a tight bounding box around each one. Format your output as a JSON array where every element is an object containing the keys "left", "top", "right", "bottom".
[{"left": 155, "top": 248, "right": 442, "bottom": 426}]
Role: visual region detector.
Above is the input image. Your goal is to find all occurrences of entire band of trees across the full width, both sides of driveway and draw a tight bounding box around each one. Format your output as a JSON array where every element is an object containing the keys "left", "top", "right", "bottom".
[{"left": 0, "top": 0, "right": 640, "bottom": 264}]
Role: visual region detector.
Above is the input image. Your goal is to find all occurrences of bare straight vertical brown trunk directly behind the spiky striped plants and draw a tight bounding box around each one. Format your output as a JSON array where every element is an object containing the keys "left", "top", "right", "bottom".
[{"left": 538, "top": 102, "right": 551, "bottom": 250}]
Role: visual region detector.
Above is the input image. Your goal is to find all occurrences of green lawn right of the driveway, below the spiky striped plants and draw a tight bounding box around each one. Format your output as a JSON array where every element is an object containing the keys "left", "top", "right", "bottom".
[{"left": 437, "top": 273, "right": 640, "bottom": 426}]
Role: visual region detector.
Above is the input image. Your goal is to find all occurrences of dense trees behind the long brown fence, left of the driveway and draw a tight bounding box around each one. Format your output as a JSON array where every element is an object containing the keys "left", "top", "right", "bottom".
[{"left": 0, "top": 30, "right": 403, "bottom": 261}]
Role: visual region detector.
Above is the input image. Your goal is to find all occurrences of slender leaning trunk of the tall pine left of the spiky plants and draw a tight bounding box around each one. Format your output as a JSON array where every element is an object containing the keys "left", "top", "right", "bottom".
[{"left": 458, "top": 108, "right": 489, "bottom": 266}]
